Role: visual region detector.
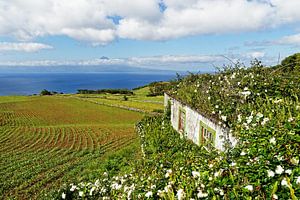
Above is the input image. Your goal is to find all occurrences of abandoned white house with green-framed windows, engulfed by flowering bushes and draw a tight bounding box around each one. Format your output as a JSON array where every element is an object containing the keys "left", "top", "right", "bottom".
[{"left": 164, "top": 93, "right": 237, "bottom": 151}]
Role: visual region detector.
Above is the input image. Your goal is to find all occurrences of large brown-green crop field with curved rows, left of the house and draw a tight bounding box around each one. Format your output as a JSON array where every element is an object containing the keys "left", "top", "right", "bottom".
[{"left": 0, "top": 96, "right": 142, "bottom": 199}]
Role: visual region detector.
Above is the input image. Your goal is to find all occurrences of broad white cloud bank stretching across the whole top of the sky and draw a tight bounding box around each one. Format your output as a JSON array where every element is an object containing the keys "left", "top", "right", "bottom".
[{"left": 0, "top": 0, "right": 300, "bottom": 45}]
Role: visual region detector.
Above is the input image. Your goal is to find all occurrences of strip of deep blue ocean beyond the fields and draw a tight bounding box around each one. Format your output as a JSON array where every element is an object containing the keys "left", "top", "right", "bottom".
[{"left": 0, "top": 73, "right": 176, "bottom": 96}]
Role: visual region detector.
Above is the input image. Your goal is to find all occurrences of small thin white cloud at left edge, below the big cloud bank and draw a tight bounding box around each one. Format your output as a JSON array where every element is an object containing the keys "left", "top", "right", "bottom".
[{"left": 0, "top": 42, "right": 53, "bottom": 52}]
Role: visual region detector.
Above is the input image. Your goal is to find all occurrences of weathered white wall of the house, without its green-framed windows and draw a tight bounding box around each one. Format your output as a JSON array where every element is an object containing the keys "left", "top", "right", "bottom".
[{"left": 164, "top": 94, "right": 237, "bottom": 151}]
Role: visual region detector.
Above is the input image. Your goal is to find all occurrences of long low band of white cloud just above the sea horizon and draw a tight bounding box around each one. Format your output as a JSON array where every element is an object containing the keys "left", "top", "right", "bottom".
[{"left": 0, "top": 55, "right": 226, "bottom": 70}]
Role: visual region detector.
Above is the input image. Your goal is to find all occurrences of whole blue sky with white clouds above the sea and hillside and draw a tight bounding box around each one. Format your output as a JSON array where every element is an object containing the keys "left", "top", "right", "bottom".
[{"left": 0, "top": 0, "right": 300, "bottom": 71}]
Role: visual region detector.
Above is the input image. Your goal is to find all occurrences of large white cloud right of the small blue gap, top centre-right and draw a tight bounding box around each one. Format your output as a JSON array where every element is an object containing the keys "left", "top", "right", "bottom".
[{"left": 118, "top": 0, "right": 272, "bottom": 40}]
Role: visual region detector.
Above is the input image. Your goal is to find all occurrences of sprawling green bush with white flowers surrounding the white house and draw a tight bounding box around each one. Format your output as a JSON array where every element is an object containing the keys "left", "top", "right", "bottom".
[{"left": 56, "top": 62, "right": 300, "bottom": 200}]
